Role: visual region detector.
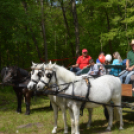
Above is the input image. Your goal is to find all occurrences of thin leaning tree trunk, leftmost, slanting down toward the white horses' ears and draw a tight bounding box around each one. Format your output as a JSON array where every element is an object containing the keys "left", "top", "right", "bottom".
[{"left": 22, "top": 0, "right": 41, "bottom": 61}]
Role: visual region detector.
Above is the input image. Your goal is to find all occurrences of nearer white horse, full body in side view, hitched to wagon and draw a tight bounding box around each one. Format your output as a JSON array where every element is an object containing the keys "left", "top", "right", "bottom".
[{"left": 37, "top": 64, "right": 123, "bottom": 134}]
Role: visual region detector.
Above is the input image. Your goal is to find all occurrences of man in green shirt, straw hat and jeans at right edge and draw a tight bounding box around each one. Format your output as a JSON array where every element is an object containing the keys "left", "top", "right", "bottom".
[{"left": 120, "top": 39, "right": 134, "bottom": 84}]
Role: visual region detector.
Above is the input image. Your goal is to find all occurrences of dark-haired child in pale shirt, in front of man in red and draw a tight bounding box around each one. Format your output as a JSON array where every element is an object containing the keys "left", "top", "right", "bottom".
[{"left": 88, "top": 59, "right": 99, "bottom": 76}]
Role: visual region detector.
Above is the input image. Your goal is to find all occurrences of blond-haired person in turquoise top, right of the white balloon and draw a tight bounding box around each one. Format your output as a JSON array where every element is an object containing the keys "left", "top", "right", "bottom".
[{"left": 110, "top": 52, "right": 122, "bottom": 76}]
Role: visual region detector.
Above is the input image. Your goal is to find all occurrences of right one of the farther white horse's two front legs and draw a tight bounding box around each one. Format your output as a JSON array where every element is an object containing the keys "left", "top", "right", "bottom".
[{"left": 60, "top": 106, "right": 68, "bottom": 134}]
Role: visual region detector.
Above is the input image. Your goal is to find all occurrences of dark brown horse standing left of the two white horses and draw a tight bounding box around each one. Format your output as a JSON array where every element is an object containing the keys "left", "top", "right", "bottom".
[{"left": 1, "top": 66, "right": 33, "bottom": 115}]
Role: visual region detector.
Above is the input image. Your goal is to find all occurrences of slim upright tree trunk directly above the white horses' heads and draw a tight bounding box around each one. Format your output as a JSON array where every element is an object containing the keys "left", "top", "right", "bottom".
[{"left": 40, "top": 0, "right": 48, "bottom": 62}]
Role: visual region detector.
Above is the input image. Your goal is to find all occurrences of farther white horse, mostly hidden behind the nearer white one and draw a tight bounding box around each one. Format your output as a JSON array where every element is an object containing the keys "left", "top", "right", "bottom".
[{"left": 27, "top": 63, "right": 92, "bottom": 134}]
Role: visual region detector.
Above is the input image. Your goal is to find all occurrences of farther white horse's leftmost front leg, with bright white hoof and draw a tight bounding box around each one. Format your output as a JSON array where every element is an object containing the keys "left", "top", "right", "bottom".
[{"left": 51, "top": 102, "right": 58, "bottom": 134}]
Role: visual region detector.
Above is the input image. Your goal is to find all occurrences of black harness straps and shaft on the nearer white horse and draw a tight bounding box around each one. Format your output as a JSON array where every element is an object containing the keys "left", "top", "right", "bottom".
[{"left": 30, "top": 69, "right": 123, "bottom": 112}]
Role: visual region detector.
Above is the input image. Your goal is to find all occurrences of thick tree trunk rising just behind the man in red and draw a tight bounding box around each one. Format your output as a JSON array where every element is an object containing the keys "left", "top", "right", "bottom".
[{"left": 71, "top": 0, "right": 80, "bottom": 57}]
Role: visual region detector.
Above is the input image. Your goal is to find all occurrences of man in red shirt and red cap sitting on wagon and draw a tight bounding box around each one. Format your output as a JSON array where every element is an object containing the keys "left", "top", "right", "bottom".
[{"left": 70, "top": 49, "right": 92, "bottom": 75}]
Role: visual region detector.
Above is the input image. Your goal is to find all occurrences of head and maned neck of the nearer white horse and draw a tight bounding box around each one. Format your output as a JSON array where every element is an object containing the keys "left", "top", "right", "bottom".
[{"left": 37, "top": 63, "right": 76, "bottom": 90}]
